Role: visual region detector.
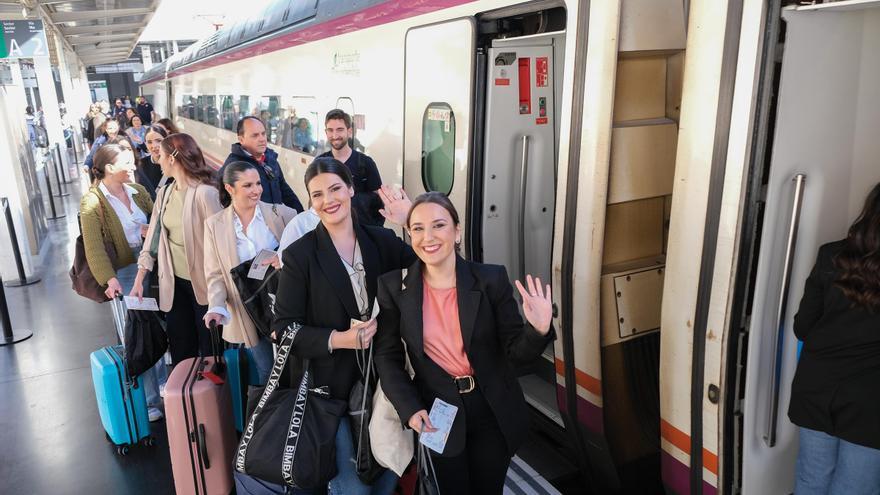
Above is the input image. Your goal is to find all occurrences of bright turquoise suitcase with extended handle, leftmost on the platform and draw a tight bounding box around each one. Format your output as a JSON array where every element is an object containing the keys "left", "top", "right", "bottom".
[{"left": 90, "top": 297, "right": 153, "bottom": 455}]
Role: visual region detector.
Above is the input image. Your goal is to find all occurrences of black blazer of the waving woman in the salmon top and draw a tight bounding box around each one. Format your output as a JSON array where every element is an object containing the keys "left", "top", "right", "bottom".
[{"left": 373, "top": 258, "right": 556, "bottom": 456}]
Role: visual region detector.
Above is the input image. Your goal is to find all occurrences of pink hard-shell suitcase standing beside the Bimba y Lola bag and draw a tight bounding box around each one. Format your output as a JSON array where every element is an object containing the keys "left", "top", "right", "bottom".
[{"left": 165, "top": 328, "right": 238, "bottom": 495}]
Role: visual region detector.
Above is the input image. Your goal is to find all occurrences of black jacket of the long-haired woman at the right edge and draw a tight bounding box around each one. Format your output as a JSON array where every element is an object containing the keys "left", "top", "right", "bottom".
[{"left": 788, "top": 241, "right": 880, "bottom": 449}]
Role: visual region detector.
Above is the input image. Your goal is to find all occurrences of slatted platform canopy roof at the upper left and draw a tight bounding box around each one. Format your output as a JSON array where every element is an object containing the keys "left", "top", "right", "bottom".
[{"left": 0, "top": 0, "right": 161, "bottom": 66}]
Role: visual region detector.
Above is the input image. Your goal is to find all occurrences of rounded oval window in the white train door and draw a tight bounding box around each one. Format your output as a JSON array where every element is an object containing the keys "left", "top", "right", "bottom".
[{"left": 422, "top": 103, "right": 455, "bottom": 195}]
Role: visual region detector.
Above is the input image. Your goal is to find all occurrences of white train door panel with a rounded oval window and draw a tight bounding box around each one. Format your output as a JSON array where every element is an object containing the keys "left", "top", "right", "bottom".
[{"left": 403, "top": 18, "right": 475, "bottom": 232}]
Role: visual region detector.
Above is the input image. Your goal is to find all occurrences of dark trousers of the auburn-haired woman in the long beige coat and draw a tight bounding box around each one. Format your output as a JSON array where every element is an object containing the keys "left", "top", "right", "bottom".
[{"left": 165, "top": 277, "right": 213, "bottom": 365}]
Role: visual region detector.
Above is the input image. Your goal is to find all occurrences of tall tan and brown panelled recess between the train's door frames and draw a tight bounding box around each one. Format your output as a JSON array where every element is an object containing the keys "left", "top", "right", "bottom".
[{"left": 600, "top": 1, "right": 686, "bottom": 493}]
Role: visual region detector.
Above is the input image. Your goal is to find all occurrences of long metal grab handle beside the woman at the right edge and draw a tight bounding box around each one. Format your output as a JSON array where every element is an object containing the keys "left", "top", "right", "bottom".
[{"left": 764, "top": 174, "right": 807, "bottom": 447}]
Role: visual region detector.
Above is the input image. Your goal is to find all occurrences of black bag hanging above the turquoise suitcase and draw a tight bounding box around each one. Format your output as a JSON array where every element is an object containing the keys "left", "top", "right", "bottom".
[{"left": 125, "top": 310, "right": 168, "bottom": 377}]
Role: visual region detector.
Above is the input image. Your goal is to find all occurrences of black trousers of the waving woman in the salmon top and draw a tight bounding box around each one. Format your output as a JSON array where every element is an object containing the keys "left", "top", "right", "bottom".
[{"left": 431, "top": 387, "right": 510, "bottom": 495}]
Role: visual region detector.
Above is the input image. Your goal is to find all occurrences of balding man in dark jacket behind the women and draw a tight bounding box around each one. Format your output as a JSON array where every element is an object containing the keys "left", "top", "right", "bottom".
[{"left": 220, "top": 115, "right": 303, "bottom": 213}]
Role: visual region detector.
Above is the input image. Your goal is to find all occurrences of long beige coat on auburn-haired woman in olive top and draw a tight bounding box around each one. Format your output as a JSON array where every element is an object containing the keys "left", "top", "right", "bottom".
[{"left": 138, "top": 181, "right": 223, "bottom": 311}]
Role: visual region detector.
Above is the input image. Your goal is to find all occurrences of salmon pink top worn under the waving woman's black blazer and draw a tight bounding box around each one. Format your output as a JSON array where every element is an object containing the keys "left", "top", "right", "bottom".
[{"left": 422, "top": 281, "right": 474, "bottom": 377}]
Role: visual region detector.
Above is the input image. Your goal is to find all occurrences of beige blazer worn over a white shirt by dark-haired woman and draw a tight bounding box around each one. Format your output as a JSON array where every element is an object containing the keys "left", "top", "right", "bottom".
[{"left": 205, "top": 201, "right": 296, "bottom": 347}]
